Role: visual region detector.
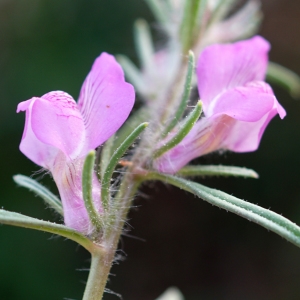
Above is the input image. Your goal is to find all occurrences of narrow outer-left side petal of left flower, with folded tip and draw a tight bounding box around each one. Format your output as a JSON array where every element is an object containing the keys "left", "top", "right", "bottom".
[{"left": 17, "top": 98, "right": 58, "bottom": 169}]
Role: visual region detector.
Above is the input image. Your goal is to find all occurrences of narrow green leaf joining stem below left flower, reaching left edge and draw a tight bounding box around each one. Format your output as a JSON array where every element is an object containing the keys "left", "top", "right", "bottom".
[{"left": 0, "top": 209, "right": 93, "bottom": 251}]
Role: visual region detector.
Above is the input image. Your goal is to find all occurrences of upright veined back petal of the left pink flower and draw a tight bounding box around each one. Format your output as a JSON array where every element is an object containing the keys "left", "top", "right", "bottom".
[{"left": 78, "top": 53, "right": 135, "bottom": 149}]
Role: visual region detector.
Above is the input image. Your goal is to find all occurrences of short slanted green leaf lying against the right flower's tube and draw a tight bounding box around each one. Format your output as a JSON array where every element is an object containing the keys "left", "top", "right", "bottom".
[{"left": 153, "top": 101, "right": 202, "bottom": 159}]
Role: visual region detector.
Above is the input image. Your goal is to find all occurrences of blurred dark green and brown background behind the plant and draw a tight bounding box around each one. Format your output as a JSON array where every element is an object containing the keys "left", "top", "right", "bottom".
[{"left": 0, "top": 0, "right": 300, "bottom": 300}]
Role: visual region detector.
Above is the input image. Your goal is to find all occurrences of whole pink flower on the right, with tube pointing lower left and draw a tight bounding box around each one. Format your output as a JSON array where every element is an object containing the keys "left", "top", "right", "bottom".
[{"left": 154, "top": 36, "right": 286, "bottom": 174}]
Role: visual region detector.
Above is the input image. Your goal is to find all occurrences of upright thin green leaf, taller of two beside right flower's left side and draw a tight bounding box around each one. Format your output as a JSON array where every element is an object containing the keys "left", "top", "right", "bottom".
[{"left": 162, "top": 51, "right": 195, "bottom": 137}]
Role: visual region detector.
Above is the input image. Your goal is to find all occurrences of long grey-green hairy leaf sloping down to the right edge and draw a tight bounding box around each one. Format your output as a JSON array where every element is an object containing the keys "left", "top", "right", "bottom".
[{"left": 146, "top": 172, "right": 300, "bottom": 247}]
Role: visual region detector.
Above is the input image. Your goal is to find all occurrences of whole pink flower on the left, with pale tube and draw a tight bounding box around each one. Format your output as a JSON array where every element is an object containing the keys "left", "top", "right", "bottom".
[{"left": 17, "top": 53, "right": 135, "bottom": 234}]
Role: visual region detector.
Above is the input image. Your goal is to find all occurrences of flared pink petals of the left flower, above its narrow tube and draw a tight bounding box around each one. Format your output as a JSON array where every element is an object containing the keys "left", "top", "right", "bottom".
[{"left": 17, "top": 53, "right": 135, "bottom": 167}]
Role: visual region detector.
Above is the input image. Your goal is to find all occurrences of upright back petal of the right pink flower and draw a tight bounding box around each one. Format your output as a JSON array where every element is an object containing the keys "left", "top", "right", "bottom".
[{"left": 197, "top": 36, "right": 270, "bottom": 113}]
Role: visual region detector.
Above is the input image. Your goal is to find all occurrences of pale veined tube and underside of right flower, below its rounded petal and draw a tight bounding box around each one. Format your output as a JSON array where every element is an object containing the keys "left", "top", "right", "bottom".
[{"left": 154, "top": 97, "right": 285, "bottom": 174}]
